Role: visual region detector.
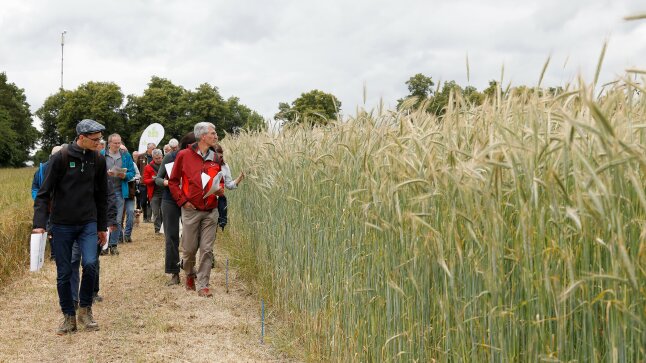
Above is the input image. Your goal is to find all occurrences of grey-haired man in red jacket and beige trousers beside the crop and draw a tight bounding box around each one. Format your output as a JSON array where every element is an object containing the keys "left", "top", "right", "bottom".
[{"left": 168, "top": 122, "right": 224, "bottom": 297}]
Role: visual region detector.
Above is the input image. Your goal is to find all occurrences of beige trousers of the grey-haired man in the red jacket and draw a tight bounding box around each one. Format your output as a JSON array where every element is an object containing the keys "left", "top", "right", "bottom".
[{"left": 181, "top": 208, "right": 218, "bottom": 290}]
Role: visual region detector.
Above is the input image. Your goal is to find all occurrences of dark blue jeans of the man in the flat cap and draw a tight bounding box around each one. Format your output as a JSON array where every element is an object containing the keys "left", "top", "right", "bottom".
[{"left": 52, "top": 222, "right": 98, "bottom": 315}]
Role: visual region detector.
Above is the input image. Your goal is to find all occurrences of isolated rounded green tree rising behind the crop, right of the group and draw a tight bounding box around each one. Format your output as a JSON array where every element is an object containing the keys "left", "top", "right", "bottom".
[{"left": 274, "top": 89, "right": 341, "bottom": 125}]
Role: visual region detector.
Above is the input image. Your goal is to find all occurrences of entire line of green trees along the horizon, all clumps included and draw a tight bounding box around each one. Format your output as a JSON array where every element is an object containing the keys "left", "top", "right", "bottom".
[{"left": 0, "top": 73, "right": 563, "bottom": 167}]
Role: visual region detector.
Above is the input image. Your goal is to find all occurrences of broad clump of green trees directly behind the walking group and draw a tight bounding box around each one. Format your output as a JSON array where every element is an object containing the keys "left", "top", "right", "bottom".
[{"left": 34, "top": 76, "right": 265, "bottom": 162}]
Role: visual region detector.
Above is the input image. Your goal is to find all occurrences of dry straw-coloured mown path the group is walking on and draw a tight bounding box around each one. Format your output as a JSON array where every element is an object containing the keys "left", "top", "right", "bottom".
[{"left": 0, "top": 223, "right": 283, "bottom": 362}]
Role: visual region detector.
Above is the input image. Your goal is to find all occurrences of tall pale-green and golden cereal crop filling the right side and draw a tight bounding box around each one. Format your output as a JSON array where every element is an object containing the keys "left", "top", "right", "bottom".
[{"left": 224, "top": 76, "right": 646, "bottom": 362}]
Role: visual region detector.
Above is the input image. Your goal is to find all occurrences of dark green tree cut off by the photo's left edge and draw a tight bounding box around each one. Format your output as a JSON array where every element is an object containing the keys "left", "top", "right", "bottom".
[{"left": 0, "top": 72, "right": 39, "bottom": 167}]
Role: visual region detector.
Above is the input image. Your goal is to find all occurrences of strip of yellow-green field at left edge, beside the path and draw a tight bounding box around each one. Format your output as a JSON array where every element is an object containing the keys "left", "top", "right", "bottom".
[{"left": 0, "top": 168, "right": 35, "bottom": 287}]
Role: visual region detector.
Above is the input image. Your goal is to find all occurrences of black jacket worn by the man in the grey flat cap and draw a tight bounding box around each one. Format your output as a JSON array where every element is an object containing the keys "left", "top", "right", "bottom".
[{"left": 34, "top": 142, "right": 108, "bottom": 231}]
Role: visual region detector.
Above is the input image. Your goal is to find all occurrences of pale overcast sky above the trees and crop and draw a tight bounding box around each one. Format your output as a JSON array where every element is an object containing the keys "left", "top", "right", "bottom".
[{"left": 0, "top": 0, "right": 646, "bottom": 128}]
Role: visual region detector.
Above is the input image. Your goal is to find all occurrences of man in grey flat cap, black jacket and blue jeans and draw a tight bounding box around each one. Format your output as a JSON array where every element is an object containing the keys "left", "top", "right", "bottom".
[{"left": 32, "top": 119, "right": 108, "bottom": 335}]
